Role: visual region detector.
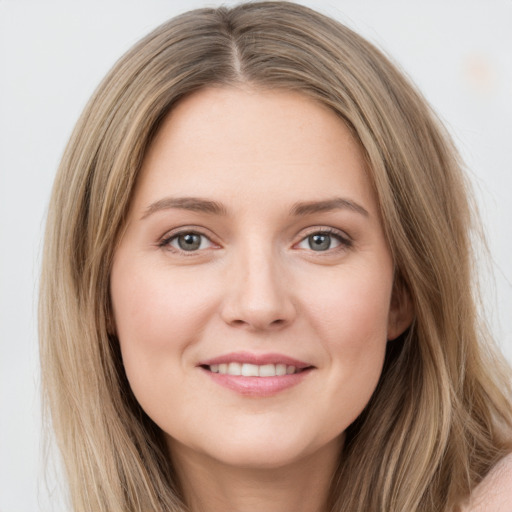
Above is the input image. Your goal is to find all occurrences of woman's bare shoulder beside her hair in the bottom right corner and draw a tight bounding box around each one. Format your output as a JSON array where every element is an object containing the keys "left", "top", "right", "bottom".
[{"left": 462, "top": 454, "right": 512, "bottom": 512}]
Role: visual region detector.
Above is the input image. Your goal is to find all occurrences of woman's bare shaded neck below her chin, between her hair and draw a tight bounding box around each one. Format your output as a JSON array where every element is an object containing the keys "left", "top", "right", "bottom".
[{"left": 172, "top": 440, "right": 341, "bottom": 512}]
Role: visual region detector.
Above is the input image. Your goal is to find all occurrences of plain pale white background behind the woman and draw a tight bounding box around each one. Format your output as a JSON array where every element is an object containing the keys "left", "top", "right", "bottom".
[{"left": 0, "top": 0, "right": 512, "bottom": 512}]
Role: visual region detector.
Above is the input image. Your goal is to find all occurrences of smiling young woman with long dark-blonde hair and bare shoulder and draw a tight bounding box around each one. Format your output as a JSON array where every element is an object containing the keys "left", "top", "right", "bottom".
[{"left": 40, "top": 2, "right": 512, "bottom": 512}]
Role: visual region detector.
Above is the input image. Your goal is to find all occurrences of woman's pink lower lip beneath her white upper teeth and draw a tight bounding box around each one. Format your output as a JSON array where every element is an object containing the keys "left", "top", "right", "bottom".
[{"left": 202, "top": 368, "right": 312, "bottom": 397}]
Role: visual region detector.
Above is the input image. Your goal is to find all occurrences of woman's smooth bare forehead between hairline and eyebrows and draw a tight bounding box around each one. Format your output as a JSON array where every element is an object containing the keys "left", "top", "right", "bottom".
[{"left": 131, "top": 87, "right": 375, "bottom": 216}]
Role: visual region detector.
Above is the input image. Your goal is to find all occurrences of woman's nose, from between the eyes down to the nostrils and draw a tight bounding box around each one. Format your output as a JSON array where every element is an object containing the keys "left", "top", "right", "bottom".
[{"left": 221, "top": 246, "right": 297, "bottom": 331}]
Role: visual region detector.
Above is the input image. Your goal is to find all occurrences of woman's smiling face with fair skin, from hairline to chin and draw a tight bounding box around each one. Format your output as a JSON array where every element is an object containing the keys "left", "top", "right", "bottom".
[{"left": 111, "top": 87, "right": 408, "bottom": 467}]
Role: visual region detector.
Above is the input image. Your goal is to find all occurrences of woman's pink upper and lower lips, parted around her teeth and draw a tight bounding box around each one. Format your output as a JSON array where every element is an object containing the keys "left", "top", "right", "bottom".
[{"left": 198, "top": 352, "right": 314, "bottom": 398}]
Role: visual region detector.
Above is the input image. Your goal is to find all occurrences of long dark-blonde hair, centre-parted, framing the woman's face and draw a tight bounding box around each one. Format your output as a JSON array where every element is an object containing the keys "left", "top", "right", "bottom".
[{"left": 40, "top": 2, "right": 512, "bottom": 512}]
